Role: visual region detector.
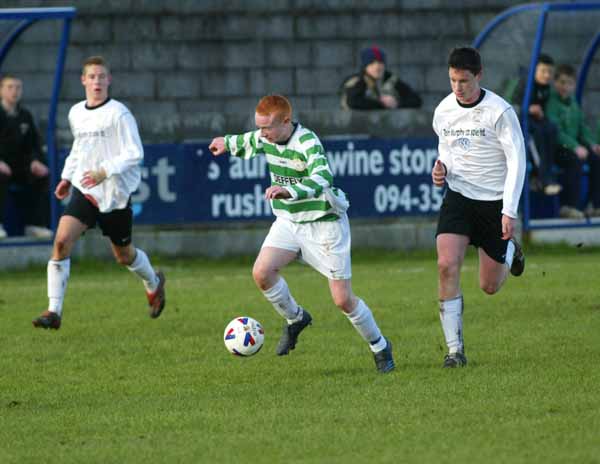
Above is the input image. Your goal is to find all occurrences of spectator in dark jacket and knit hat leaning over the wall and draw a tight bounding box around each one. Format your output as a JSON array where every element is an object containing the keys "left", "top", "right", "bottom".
[{"left": 342, "top": 46, "right": 422, "bottom": 110}]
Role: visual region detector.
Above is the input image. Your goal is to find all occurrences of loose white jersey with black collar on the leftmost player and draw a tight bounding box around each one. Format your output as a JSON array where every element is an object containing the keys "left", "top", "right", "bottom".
[{"left": 61, "top": 99, "right": 144, "bottom": 213}]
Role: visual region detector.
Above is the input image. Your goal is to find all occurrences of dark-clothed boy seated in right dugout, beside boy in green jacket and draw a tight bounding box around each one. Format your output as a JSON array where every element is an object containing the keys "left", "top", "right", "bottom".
[{"left": 512, "top": 54, "right": 562, "bottom": 195}]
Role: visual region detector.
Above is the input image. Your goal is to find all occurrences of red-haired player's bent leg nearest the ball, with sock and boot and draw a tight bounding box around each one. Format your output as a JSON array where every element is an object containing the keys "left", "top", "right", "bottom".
[{"left": 252, "top": 247, "right": 312, "bottom": 356}]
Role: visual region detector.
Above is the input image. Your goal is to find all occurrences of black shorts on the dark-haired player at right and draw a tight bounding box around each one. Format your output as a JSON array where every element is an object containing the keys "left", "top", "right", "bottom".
[{"left": 436, "top": 189, "right": 508, "bottom": 263}]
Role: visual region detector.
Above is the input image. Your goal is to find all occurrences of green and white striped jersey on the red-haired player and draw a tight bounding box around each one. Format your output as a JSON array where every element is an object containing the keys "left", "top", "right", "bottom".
[{"left": 225, "top": 124, "right": 349, "bottom": 222}]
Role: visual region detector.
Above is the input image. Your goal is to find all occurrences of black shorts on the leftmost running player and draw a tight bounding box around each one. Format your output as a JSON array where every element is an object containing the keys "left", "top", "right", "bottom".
[{"left": 63, "top": 187, "right": 133, "bottom": 247}]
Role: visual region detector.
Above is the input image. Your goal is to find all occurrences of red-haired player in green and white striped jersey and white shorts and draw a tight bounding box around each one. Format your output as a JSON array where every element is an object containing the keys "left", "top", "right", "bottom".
[{"left": 209, "top": 95, "right": 394, "bottom": 373}]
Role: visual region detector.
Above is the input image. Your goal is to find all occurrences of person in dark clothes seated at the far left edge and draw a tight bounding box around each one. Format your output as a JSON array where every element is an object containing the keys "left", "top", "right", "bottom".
[{"left": 0, "top": 74, "right": 52, "bottom": 238}]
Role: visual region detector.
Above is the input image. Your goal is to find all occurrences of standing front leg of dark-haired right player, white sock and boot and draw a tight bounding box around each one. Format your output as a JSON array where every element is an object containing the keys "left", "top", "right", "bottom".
[{"left": 436, "top": 234, "right": 469, "bottom": 367}]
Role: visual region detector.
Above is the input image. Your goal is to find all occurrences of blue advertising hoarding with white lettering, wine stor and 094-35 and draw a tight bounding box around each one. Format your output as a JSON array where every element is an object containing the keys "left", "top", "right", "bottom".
[{"left": 56, "top": 138, "right": 442, "bottom": 224}]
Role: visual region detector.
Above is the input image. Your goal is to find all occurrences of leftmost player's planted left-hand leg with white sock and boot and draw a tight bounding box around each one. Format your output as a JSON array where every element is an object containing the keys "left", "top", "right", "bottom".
[{"left": 32, "top": 216, "right": 87, "bottom": 330}]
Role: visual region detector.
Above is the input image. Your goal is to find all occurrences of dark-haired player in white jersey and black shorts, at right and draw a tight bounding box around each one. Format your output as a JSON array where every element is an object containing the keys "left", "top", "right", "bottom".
[{"left": 431, "top": 47, "right": 525, "bottom": 367}]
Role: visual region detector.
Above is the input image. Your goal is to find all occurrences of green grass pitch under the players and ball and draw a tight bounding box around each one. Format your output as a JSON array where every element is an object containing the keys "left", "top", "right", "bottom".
[{"left": 0, "top": 248, "right": 600, "bottom": 464}]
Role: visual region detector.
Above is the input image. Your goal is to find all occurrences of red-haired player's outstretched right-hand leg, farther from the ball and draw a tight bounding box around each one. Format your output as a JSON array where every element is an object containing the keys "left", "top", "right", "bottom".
[{"left": 329, "top": 279, "right": 395, "bottom": 373}]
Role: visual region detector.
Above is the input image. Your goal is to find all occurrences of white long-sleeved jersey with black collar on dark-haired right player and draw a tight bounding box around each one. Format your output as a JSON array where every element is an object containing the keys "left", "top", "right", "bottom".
[{"left": 433, "top": 89, "right": 525, "bottom": 218}]
